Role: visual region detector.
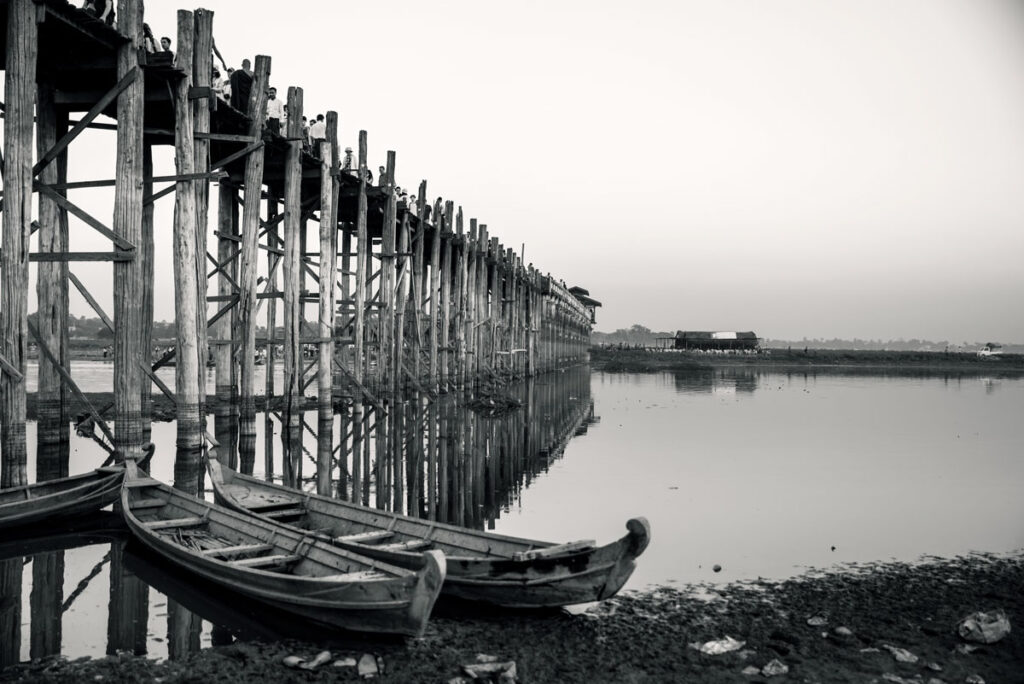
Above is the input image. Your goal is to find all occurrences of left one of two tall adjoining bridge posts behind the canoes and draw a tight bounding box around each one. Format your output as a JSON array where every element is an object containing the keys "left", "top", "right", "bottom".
[{"left": 172, "top": 10, "right": 205, "bottom": 494}]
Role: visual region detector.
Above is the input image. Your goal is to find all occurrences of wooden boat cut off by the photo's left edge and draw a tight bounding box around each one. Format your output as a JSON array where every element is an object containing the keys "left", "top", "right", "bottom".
[{"left": 0, "top": 466, "right": 124, "bottom": 529}]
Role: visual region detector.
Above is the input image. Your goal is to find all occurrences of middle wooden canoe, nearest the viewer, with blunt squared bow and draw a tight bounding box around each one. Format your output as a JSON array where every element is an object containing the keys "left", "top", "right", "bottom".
[{"left": 121, "top": 462, "right": 445, "bottom": 636}]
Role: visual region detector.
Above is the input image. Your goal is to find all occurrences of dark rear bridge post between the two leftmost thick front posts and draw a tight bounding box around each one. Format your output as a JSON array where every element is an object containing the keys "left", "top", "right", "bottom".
[{"left": 36, "top": 85, "right": 71, "bottom": 471}]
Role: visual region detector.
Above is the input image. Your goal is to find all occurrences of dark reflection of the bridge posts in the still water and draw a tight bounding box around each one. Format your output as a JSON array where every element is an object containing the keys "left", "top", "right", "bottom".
[{"left": 0, "top": 367, "right": 597, "bottom": 667}]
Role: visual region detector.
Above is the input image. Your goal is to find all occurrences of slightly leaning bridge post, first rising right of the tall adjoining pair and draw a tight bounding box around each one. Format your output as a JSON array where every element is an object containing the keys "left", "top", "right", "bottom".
[{"left": 231, "top": 54, "right": 270, "bottom": 471}]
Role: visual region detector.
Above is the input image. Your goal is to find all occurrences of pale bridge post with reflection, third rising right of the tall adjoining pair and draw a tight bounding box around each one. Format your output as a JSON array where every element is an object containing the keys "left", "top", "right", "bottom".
[{"left": 316, "top": 135, "right": 338, "bottom": 497}]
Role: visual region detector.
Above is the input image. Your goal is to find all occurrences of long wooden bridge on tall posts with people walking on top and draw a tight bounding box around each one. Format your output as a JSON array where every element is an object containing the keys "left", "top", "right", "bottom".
[{"left": 0, "top": 0, "right": 596, "bottom": 491}]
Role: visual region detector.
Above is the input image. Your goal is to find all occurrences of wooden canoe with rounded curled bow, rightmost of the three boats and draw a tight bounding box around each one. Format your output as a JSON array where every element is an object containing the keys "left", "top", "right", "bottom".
[{"left": 207, "top": 456, "right": 650, "bottom": 607}]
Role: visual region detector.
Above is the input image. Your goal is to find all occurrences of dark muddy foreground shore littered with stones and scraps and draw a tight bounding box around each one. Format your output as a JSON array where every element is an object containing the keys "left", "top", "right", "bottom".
[{"left": 0, "top": 554, "right": 1024, "bottom": 684}]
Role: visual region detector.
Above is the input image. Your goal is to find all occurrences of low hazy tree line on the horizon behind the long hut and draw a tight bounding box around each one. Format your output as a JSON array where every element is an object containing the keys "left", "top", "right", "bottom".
[{"left": 590, "top": 324, "right": 1024, "bottom": 353}]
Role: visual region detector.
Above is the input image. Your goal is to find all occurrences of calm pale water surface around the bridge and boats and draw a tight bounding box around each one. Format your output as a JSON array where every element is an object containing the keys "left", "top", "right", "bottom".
[{"left": 0, "top": 364, "right": 1024, "bottom": 660}]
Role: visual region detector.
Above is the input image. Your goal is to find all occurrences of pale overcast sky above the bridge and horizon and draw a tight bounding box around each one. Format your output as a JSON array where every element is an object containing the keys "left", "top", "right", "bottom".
[{"left": 14, "top": 0, "right": 1024, "bottom": 342}]
